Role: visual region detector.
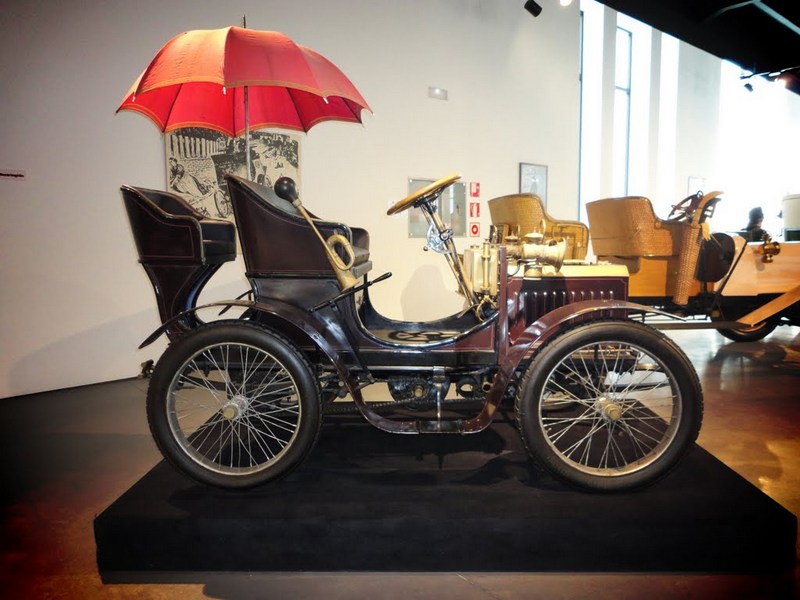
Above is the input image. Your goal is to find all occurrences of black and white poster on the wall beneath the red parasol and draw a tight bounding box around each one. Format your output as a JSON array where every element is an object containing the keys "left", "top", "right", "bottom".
[{"left": 164, "top": 127, "right": 300, "bottom": 221}]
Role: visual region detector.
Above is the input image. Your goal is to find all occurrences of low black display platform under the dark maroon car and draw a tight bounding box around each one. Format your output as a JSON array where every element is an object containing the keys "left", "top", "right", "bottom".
[{"left": 95, "top": 417, "right": 797, "bottom": 581}]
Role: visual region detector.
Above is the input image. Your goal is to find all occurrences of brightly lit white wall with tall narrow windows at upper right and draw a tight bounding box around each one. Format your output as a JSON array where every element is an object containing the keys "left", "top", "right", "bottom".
[{"left": 581, "top": 0, "right": 800, "bottom": 229}]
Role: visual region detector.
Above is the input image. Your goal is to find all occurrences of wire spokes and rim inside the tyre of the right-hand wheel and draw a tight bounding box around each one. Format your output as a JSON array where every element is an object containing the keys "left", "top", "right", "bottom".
[{"left": 539, "top": 340, "right": 680, "bottom": 476}]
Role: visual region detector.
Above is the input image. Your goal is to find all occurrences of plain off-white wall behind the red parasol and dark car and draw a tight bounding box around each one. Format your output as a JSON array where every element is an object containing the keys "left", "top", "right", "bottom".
[{"left": 0, "top": 0, "right": 579, "bottom": 397}]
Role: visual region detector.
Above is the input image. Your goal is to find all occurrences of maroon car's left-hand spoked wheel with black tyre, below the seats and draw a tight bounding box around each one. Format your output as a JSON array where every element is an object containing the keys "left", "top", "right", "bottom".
[{"left": 147, "top": 321, "right": 321, "bottom": 488}]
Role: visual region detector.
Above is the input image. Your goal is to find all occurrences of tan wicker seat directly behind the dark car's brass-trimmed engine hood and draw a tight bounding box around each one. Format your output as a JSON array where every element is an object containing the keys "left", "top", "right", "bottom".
[{"left": 489, "top": 194, "right": 589, "bottom": 260}]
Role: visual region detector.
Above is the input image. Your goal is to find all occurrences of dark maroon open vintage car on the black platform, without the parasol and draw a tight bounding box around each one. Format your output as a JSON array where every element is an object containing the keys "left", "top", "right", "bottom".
[{"left": 122, "top": 173, "right": 703, "bottom": 491}]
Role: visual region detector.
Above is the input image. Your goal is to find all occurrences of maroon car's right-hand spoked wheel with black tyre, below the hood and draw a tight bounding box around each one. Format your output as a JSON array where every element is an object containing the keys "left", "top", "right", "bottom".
[{"left": 515, "top": 321, "right": 703, "bottom": 491}]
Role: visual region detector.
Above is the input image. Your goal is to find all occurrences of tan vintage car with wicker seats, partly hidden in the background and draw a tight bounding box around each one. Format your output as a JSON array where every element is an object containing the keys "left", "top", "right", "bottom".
[{"left": 489, "top": 192, "right": 800, "bottom": 341}]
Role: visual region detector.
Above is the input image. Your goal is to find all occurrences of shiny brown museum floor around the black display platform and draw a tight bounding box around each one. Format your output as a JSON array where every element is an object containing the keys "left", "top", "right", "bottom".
[{"left": 0, "top": 327, "right": 800, "bottom": 600}]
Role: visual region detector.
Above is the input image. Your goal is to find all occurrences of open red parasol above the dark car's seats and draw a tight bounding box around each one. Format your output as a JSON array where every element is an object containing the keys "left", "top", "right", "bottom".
[{"left": 117, "top": 27, "right": 370, "bottom": 136}]
